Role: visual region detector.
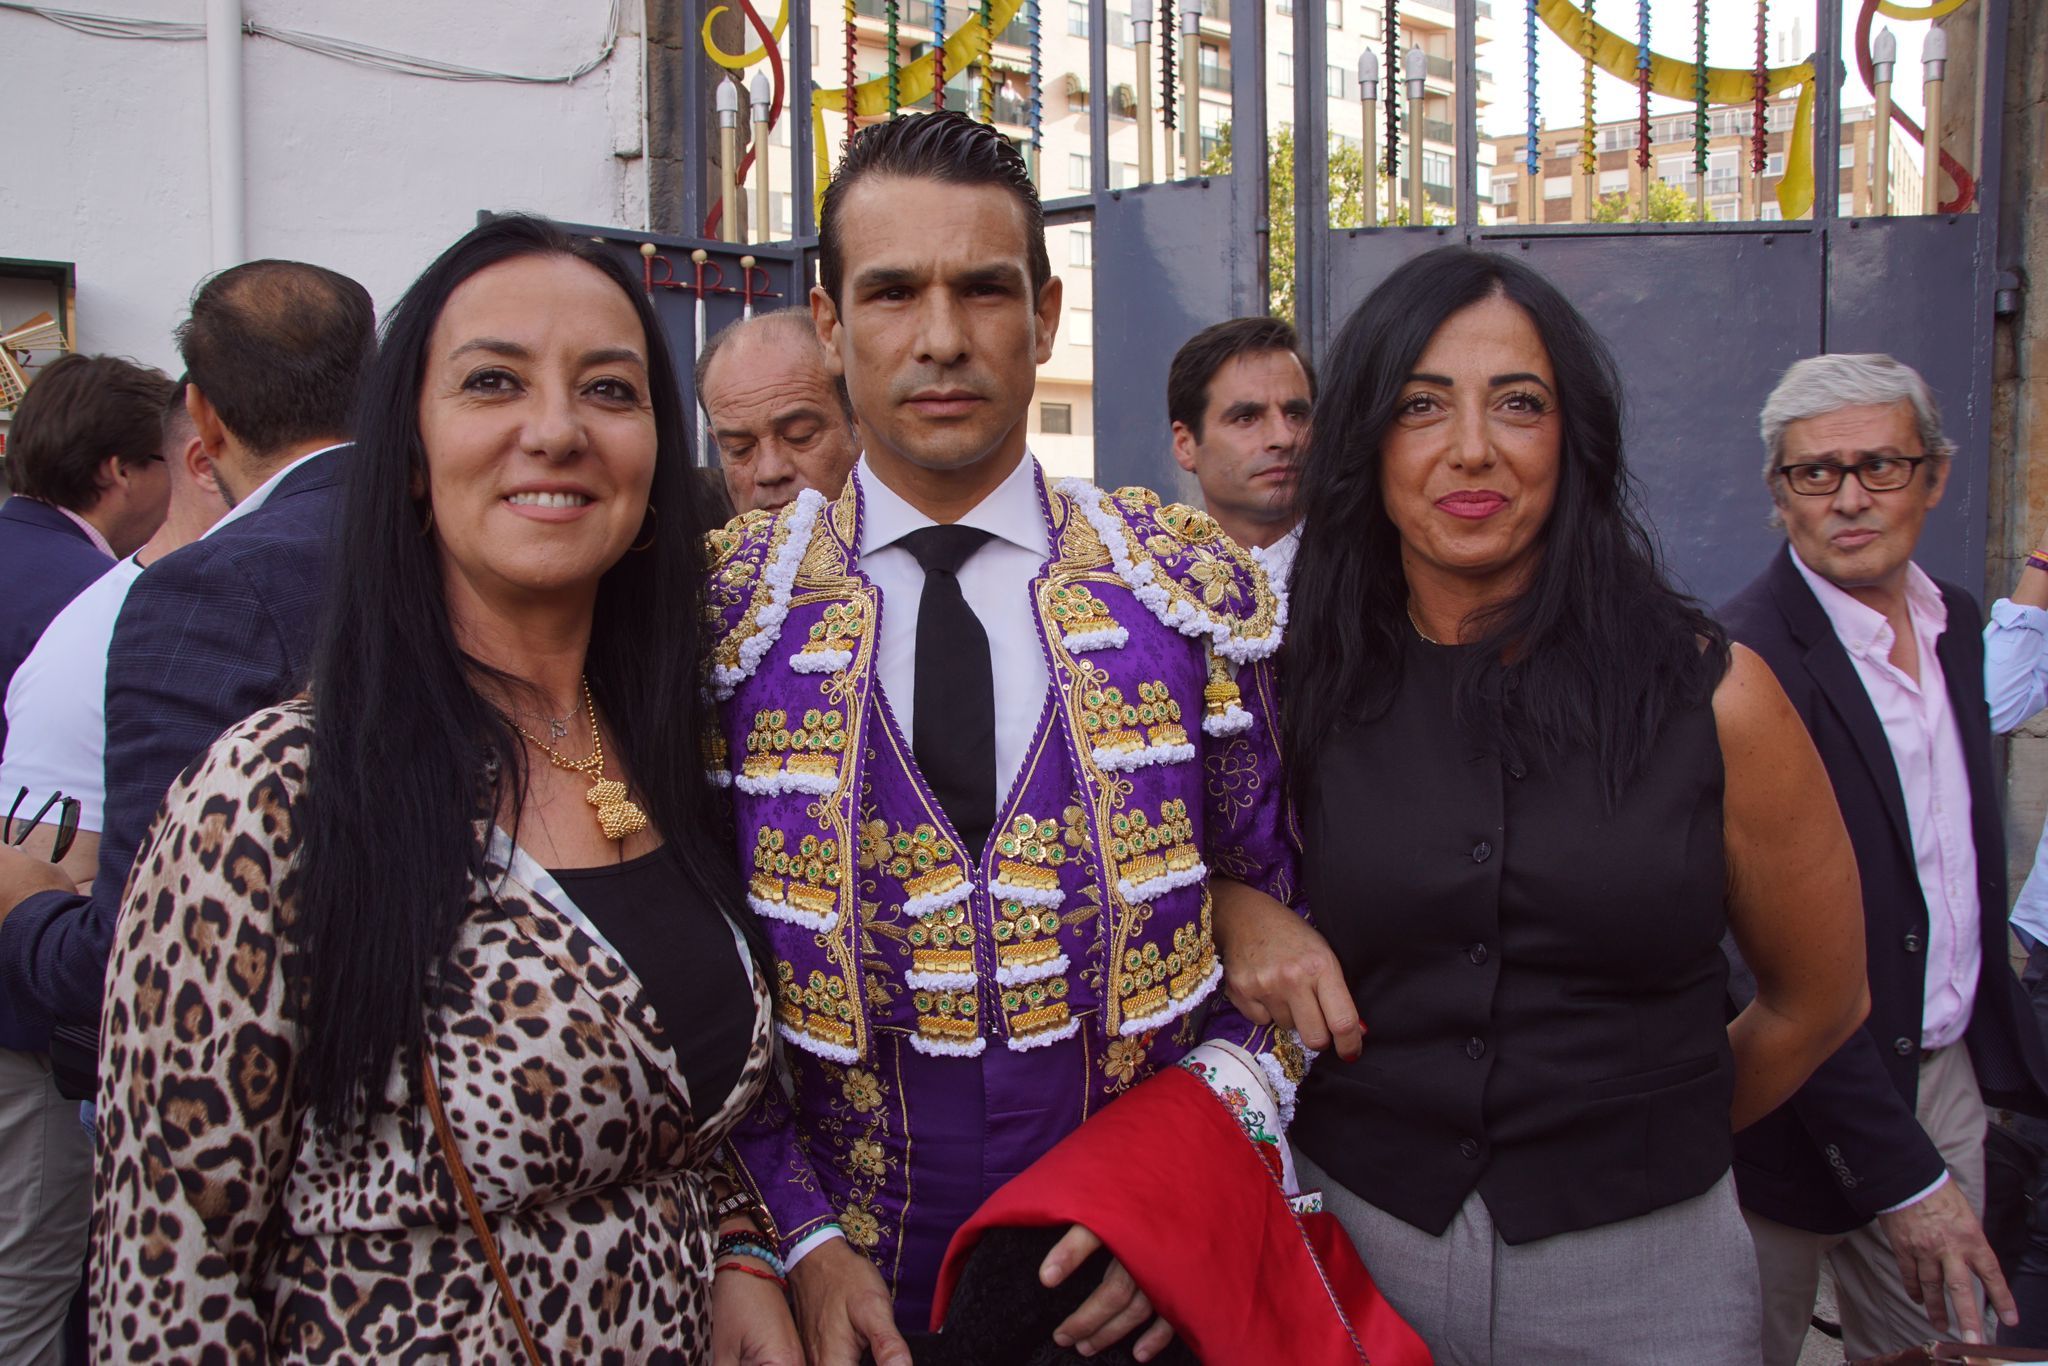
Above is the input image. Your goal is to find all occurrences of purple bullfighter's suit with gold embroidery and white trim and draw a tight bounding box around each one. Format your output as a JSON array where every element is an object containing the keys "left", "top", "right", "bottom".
[{"left": 711, "top": 466, "right": 1305, "bottom": 1327}]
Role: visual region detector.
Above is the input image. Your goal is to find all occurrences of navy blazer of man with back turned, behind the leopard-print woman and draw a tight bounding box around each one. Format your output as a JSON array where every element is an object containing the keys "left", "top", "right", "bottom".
[{"left": 0, "top": 451, "right": 346, "bottom": 1049}]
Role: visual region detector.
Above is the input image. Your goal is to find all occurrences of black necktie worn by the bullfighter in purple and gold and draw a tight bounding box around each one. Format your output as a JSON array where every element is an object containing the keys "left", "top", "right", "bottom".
[{"left": 901, "top": 526, "right": 995, "bottom": 858}]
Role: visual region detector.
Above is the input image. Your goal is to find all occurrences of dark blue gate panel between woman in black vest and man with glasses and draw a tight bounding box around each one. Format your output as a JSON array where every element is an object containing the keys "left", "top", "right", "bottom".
[{"left": 1481, "top": 231, "right": 1823, "bottom": 604}]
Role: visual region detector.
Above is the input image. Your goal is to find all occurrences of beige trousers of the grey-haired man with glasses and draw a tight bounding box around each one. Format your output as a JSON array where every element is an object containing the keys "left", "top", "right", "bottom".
[{"left": 1745, "top": 1044, "right": 1993, "bottom": 1366}]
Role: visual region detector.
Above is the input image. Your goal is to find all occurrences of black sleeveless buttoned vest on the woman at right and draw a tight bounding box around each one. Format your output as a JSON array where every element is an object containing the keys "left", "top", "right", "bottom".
[{"left": 1290, "top": 641, "right": 1735, "bottom": 1243}]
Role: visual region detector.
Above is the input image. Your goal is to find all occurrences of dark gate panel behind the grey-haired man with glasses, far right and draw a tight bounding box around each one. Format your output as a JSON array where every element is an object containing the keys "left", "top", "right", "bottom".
[{"left": 1827, "top": 213, "right": 1993, "bottom": 594}]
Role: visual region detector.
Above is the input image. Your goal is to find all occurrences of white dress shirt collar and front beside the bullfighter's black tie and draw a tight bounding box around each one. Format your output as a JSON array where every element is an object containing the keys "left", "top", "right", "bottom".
[{"left": 854, "top": 451, "right": 1053, "bottom": 811}]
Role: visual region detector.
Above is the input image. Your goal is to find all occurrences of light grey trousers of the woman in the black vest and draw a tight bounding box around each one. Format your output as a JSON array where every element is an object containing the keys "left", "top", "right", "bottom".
[{"left": 1294, "top": 1149, "right": 1759, "bottom": 1366}]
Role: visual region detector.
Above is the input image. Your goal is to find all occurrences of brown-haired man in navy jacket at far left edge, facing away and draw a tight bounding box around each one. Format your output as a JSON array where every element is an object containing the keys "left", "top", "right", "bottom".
[{"left": 0, "top": 356, "right": 170, "bottom": 757}]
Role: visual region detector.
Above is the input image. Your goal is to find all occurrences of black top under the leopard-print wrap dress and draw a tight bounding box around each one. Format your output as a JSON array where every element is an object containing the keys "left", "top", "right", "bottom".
[{"left": 549, "top": 846, "right": 754, "bottom": 1124}]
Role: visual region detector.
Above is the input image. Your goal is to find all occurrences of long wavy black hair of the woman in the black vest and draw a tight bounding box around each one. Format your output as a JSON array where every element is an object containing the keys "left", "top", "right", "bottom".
[{"left": 1284, "top": 246, "right": 1729, "bottom": 801}]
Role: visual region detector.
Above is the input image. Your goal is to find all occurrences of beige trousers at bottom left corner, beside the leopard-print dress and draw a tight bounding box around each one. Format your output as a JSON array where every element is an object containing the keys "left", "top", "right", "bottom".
[{"left": 0, "top": 1049, "right": 92, "bottom": 1366}]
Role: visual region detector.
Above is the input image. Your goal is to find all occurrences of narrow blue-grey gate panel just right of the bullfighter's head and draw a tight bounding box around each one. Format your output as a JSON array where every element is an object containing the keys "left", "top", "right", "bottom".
[{"left": 1094, "top": 178, "right": 1257, "bottom": 506}]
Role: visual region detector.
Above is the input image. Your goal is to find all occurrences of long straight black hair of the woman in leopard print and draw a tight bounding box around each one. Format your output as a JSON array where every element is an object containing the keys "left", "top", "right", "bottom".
[{"left": 289, "top": 215, "right": 748, "bottom": 1133}]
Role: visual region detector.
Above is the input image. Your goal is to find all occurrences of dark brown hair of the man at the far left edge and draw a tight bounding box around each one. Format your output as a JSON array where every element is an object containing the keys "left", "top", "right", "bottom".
[{"left": 6, "top": 354, "right": 170, "bottom": 512}]
